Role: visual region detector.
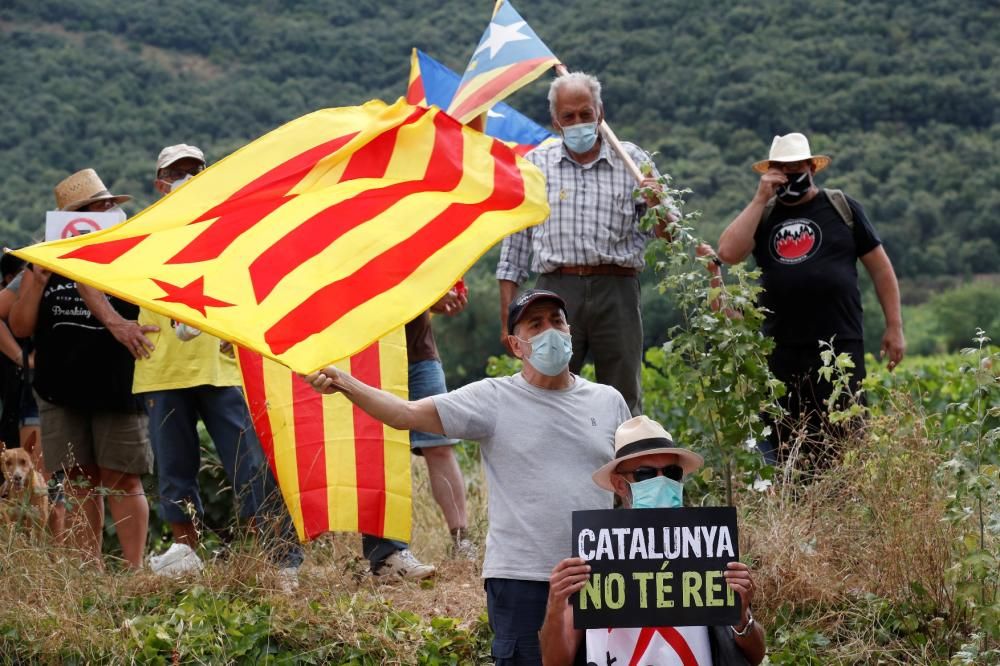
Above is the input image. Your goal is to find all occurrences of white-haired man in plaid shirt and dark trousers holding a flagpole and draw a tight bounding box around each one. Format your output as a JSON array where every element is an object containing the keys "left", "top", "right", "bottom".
[{"left": 496, "top": 72, "right": 666, "bottom": 415}]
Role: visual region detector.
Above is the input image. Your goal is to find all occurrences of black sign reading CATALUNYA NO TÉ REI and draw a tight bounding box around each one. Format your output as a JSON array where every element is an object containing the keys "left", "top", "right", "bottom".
[{"left": 572, "top": 507, "right": 740, "bottom": 629}]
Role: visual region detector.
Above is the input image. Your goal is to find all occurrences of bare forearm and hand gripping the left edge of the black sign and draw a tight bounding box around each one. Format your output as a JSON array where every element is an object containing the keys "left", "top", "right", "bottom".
[{"left": 538, "top": 557, "right": 590, "bottom": 666}]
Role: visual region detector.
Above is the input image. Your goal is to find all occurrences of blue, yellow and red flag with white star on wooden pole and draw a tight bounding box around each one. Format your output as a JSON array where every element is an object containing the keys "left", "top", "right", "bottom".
[{"left": 447, "top": 0, "right": 559, "bottom": 123}]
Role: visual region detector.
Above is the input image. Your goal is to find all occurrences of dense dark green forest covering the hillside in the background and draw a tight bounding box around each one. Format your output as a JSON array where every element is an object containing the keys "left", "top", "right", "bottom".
[{"left": 0, "top": 0, "right": 1000, "bottom": 380}]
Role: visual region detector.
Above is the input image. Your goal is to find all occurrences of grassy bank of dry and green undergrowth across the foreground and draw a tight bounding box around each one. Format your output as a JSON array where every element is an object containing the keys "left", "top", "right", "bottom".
[{"left": 0, "top": 349, "right": 1000, "bottom": 664}]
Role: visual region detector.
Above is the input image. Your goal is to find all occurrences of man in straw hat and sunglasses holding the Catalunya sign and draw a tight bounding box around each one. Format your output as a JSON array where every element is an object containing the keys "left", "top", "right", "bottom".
[{"left": 540, "top": 416, "right": 765, "bottom": 666}]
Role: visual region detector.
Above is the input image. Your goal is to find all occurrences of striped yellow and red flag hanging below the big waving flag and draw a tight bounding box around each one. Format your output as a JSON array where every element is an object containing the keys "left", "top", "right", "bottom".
[{"left": 238, "top": 327, "right": 411, "bottom": 541}]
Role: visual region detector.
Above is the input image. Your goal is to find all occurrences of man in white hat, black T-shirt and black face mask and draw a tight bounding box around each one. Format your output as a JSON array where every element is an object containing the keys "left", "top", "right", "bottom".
[{"left": 718, "top": 133, "right": 906, "bottom": 462}]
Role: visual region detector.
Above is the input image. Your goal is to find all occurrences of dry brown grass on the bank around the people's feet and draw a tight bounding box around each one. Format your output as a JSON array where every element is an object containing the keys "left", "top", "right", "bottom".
[{"left": 0, "top": 421, "right": 972, "bottom": 664}]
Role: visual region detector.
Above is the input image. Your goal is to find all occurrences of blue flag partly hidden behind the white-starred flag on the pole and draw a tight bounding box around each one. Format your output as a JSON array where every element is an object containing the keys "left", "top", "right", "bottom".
[{"left": 406, "top": 49, "right": 556, "bottom": 155}]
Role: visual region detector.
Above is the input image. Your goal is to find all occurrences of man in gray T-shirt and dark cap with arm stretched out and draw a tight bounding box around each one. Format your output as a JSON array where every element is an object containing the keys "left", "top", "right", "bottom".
[{"left": 305, "top": 289, "right": 631, "bottom": 666}]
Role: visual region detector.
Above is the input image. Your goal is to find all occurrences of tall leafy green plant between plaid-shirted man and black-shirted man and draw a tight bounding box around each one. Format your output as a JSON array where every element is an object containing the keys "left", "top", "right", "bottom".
[{"left": 644, "top": 176, "right": 783, "bottom": 504}]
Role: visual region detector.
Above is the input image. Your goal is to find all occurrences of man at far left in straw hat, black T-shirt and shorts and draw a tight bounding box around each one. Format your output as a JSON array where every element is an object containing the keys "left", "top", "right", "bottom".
[{"left": 10, "top": 169, "right": 153, "bottom": 569}]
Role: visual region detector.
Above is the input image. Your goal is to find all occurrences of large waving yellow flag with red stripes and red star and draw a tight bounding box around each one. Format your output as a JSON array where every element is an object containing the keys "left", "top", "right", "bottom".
[{"left": 15, "top": 100, "right": 548, "bottom": 373}]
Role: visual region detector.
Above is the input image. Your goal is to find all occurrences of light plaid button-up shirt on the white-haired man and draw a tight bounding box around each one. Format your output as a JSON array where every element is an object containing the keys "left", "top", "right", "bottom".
[{"left": 496, "top": 141, "right": 672, "bottom": 284}]
